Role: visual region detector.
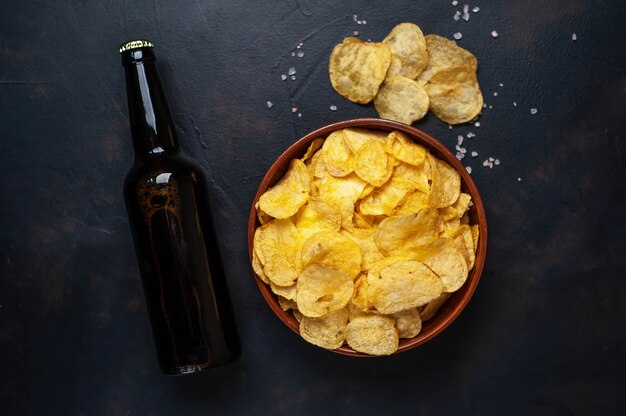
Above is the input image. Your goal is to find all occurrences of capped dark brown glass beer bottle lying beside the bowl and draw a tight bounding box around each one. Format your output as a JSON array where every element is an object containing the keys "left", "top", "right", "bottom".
[{"left": 120, "top": 40, "right": 240, "bottom": 375}]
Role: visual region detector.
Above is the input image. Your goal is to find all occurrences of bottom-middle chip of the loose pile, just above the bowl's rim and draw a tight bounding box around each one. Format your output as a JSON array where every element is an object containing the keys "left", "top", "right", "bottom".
[{"left": 374, "top": 76, "right": 430, "bottom": 125}]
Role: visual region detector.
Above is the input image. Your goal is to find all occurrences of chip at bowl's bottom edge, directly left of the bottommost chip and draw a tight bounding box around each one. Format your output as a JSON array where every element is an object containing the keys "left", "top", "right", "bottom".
[{"left": 300, "top": 308, "right": 348, "bottom": 350}]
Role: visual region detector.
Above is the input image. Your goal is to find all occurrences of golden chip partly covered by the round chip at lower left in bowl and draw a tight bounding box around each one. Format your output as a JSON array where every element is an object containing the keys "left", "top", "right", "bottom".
[{"left": 302, "top": 231, "right": 361, "bottom": 280}]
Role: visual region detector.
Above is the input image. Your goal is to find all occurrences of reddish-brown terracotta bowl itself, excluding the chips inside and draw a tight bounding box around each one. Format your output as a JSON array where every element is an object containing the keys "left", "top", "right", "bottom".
[{"left": 248, "top": 118, "right": 487, "bottom": 357}]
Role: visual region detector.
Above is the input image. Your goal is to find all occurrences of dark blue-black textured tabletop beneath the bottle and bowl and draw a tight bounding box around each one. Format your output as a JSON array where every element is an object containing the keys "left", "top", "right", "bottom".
[{"left": 0, "top": 0, "right": 626, "bottom": 415}]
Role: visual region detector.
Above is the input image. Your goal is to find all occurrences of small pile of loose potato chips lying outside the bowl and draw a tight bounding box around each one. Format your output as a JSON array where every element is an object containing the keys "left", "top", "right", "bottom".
[{"left": 328, "top": 23, "right": 483, "bottom": 124}]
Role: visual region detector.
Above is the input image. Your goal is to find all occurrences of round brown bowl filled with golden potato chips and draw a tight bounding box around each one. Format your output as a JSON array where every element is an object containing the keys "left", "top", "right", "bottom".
[{"left": 248, "top": 119, "right": 487, "bottom": 356}]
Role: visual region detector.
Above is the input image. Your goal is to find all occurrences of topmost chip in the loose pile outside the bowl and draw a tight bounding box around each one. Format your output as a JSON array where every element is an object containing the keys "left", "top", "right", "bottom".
[{"left": 383, "top": 23, "right": 428, "bottom": 79}]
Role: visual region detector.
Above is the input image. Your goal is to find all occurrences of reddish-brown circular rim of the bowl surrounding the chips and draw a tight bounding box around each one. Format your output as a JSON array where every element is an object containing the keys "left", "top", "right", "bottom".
[{"left": 248, "top": 118, "right": 488, "bottom": 357}]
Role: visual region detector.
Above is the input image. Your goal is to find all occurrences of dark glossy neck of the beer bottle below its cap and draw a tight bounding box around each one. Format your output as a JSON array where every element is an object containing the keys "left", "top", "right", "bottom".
[{"left": 122, "top": 48, "right": 178, "bottom": 159}]
